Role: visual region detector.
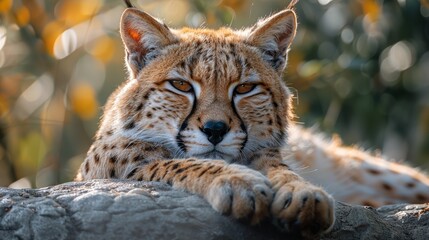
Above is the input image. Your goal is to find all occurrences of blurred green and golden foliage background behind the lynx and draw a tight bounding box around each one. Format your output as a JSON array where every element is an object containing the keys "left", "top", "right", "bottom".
[{"left": 0, "top": 0, "right": 429, "bottom": 187}]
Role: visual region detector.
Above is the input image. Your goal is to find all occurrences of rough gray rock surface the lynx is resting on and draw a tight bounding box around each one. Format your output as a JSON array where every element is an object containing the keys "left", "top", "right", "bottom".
[{"left": 0, "top": 180, "right": 429, "bottom": 240}]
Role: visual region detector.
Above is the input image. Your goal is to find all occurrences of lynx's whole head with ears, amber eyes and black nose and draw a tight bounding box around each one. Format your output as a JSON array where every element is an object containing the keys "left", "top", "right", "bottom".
[{"left": 112, "top": 2, "right": 297, "bottom": 161}]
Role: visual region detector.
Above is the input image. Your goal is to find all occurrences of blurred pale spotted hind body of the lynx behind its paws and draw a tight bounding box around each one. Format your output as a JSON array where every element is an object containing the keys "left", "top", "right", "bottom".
[{"left": 282, "top": 126, "right": 429, "bottom": 207}]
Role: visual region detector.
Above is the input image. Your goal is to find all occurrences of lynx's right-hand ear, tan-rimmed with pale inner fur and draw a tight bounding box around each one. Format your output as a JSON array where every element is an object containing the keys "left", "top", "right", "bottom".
[{"left": 247, "top": 9, "right": 297, "bottom": 73}]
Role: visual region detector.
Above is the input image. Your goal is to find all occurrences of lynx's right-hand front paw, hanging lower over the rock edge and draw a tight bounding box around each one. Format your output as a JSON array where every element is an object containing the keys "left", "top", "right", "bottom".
[{"left": 271, "top": 181, "right": 335, "bottom": 238}]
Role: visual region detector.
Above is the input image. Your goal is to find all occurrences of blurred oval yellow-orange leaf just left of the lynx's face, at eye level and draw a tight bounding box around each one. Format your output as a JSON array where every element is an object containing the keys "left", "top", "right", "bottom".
[{"left": 70, "top": 83, "right": 98, "bottom": 119}]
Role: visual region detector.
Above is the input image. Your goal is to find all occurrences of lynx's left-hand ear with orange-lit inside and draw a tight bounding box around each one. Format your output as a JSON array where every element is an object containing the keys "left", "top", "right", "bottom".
[{"left": 120, "top": 8, "right": 177, "bottom": 78}]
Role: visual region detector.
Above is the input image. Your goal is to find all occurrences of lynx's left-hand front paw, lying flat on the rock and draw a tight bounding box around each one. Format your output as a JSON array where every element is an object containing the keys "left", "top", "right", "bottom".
[{"left": 206, "top": 165, "right": 274, "bottom": 224}]
